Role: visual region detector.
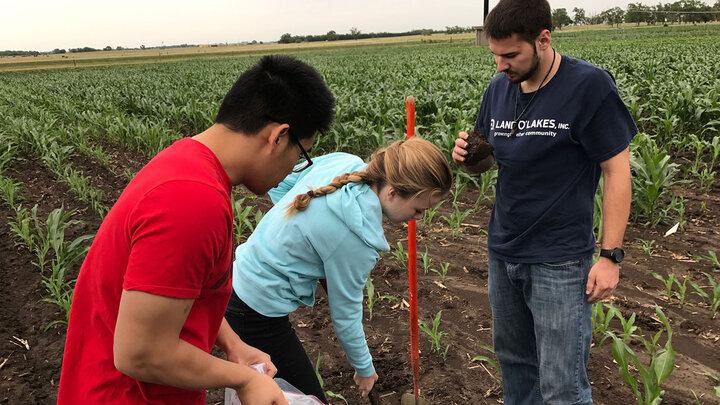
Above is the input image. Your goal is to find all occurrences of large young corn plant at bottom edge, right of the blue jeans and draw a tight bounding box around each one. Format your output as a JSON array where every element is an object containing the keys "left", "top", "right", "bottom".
[{"left": 606, "top": 306, "right": 675, "bottom": 405}]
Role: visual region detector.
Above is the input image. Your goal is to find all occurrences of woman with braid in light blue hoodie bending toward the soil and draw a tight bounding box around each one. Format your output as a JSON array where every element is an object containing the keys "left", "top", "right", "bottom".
[{"left": 225, "top": 137, "right": 452, "bottom": 402}]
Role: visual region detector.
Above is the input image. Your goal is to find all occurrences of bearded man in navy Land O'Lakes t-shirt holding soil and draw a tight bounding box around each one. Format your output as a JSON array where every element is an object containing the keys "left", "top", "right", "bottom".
[{"left": 453, "top": 0, "right": 637, "bottom": 404}]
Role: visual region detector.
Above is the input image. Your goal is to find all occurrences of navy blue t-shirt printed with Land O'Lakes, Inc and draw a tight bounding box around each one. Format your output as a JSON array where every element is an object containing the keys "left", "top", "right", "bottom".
[{"left": 475, "top": 56, "right": 637, "bottom": 263}]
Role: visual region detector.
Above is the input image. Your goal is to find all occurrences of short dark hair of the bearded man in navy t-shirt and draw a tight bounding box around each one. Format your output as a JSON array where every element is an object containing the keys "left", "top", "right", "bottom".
[{"left": 483, "top": 0, "right": 552, "bottom": 45}]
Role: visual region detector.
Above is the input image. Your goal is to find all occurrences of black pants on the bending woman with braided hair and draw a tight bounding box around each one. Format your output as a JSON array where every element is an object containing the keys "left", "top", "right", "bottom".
[{"left": 225, "top": 291, "right": 327, "bottom": 403}]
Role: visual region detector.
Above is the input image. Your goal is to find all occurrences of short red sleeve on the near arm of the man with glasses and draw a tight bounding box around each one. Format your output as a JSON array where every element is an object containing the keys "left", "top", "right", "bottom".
[{"left": 123, "top": 181, "right": 232, "bottom": 299}]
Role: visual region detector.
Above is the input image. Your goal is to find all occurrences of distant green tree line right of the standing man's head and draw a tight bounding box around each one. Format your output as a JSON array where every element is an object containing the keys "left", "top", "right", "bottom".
[{"left": 552, "top": 0, "right": 720, "bottom": 29}]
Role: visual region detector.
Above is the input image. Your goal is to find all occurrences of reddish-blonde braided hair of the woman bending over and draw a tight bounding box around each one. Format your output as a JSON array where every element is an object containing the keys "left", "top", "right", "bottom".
[{"left": 286, "top": 137, "right": 452, "bottom": 217}]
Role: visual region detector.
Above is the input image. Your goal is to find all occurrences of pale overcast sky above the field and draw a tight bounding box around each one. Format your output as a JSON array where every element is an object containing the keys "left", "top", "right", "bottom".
[{"left": 0, "top": 0, "right": 644, "bottom": 52}]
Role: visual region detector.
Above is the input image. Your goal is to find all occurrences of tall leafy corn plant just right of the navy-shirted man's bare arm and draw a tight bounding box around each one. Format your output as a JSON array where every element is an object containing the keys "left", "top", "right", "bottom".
[{"left": 630, "top": 133, "right": 681, "bottom": 227}]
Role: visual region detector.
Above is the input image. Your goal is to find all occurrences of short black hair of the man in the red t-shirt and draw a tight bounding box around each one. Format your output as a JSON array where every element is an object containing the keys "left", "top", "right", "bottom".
[{"left": 215, "top": 55, "right": 335, "bottom": 139}]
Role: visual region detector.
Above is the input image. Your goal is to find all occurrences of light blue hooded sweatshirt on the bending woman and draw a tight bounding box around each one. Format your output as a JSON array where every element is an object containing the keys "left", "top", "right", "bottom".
[{"left": 233, "top": 153, "right": 390, "bottom": 377}]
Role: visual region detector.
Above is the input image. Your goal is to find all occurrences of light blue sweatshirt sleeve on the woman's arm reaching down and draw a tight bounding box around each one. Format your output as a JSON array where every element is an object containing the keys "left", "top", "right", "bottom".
[{"left": 324, "top": 233, "right": 380, "bottom": 377}]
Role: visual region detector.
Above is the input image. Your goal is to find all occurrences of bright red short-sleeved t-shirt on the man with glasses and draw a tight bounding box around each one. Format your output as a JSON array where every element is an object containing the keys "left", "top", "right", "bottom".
[{"left": 58, "top": 139, "right": 233, "bottom": 405}]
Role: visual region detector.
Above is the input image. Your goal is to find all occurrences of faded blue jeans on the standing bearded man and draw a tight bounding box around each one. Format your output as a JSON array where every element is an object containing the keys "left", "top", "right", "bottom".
[{"left": 488, "top": 253, "right": 592, "bottom": 405}]
